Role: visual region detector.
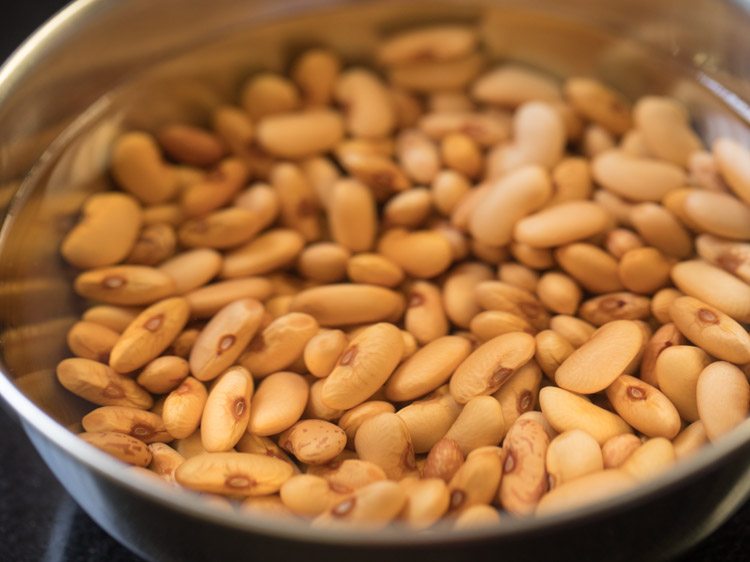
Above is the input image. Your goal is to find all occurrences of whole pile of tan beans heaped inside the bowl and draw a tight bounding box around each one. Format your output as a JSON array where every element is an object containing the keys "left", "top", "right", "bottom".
[{"left": 57, "top": 26, "right": 750, "bottom": 529}]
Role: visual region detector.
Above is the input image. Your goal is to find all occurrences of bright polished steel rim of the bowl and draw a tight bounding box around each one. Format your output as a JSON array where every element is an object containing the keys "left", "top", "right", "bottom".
[{"left": 0, "top": 0, "right": 750, "bottom": 548}]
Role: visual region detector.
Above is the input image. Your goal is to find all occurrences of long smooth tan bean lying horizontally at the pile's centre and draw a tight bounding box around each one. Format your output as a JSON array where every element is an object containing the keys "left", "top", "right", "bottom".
[{"left": 290, "top": 284, "right": 405, "bottom": 326}]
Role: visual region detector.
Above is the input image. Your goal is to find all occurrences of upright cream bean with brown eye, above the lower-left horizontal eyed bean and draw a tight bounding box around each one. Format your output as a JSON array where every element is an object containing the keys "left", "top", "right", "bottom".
[{"left": 201, "top": 367, "right": 254, "bottom": 453}]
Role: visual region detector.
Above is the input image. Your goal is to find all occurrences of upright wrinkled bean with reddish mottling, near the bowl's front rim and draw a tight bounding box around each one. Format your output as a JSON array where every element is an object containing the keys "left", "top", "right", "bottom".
[{"left": 498, "top": 420, "right": 549, "bottom": 515}]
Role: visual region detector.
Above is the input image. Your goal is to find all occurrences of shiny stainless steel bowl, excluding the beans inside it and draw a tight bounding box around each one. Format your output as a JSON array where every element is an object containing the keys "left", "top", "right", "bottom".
[{"left": 0, "top": 0, "right": 750, "bottom": 561}]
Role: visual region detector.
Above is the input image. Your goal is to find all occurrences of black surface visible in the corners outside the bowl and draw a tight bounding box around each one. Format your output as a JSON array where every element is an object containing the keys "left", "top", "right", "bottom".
[{"left": 0, "top": 0, "right": 750, "bottom": 562}]
